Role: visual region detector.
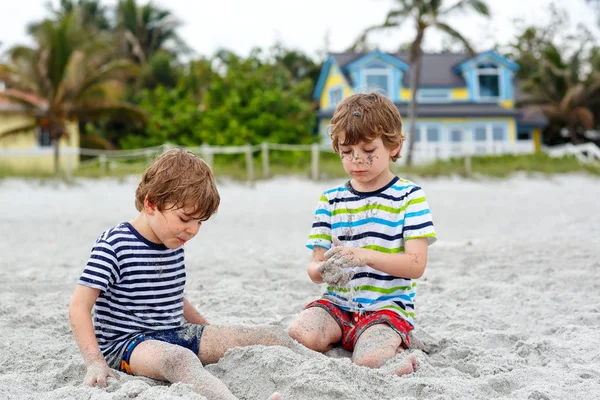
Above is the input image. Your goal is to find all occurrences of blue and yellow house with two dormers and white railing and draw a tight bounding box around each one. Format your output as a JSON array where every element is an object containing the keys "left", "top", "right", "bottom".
[{"left": 314, "top": 50, "right": 547, "bottom": 162}]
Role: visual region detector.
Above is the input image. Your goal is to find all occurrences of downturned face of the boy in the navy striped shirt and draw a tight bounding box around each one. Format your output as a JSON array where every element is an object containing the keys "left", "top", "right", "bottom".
[{"left": 144, "top": 199, "right": 202, "bottom": 249}]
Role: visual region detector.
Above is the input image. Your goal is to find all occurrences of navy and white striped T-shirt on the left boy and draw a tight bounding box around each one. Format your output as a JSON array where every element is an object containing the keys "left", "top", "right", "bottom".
[{"left": 78, "top": 222, "right": 186, "bottom": 368}]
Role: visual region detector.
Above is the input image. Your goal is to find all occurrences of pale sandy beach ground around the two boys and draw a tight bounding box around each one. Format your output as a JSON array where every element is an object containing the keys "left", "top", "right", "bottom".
[{"left": 0, "top": 176, "right": 600, "bottom": 400}]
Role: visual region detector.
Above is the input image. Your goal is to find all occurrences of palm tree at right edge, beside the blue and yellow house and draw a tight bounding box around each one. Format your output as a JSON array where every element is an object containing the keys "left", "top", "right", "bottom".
[{"left": 508, "top": 8, "right": 600, "bottom": 143}]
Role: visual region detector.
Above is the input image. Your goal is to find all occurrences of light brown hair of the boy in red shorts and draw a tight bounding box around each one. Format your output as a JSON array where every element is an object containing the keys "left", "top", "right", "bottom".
[{"left": 329, "top": 93, "right": 404, "bottom": 161}]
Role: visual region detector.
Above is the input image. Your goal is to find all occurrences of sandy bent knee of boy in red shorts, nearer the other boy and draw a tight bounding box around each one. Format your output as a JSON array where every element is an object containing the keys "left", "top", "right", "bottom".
[{"left": 288, "top": 307, "right": 342, "bottom": 353}]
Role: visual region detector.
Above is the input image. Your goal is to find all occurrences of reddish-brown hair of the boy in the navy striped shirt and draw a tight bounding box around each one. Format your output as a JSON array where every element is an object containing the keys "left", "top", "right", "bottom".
[{"left": 135, "top": 149, "right": 221, "bottom": 221}]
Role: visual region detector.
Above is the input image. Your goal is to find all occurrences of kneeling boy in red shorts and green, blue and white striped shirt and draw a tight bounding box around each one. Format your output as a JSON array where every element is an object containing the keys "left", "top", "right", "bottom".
[{"left": 288, "top": 93, "right": 436, "bottom": 375}]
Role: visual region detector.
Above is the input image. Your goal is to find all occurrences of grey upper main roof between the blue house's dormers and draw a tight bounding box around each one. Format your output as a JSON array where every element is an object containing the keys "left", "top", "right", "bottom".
[{"left": 331, "top": 52, "right": 472, "bottom": 87}]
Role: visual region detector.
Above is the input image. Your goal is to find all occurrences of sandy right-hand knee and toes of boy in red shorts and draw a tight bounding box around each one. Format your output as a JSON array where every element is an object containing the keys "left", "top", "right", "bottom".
[{"left": 352, "top": 324, "right": 417, "bottom": 375}]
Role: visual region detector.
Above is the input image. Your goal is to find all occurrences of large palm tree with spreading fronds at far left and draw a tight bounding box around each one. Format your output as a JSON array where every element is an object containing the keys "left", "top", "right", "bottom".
[{"left": 0, "top": 13, "right": 145, "bottom": 172}]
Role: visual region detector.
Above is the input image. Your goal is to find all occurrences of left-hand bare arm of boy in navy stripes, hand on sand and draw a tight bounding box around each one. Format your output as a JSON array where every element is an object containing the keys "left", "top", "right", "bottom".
[{"left": 69, "top": 285, "right": 115, "bottom": 387}]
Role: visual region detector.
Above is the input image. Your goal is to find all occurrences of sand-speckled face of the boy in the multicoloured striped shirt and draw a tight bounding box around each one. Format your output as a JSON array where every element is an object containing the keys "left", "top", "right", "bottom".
[{"left": 339, "top": 133, "right": 400, "bottom": 190}]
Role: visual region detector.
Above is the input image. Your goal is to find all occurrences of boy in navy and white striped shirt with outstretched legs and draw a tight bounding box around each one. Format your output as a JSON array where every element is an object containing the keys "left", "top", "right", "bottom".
[{"left": 69, "top": 149, "right": 284, "bottom": 399}]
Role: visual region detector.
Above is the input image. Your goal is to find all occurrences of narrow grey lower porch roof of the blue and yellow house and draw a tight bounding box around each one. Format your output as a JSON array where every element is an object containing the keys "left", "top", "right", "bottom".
[{"left": 319, "top": 103, "right": 519, "bottom": 119}]
